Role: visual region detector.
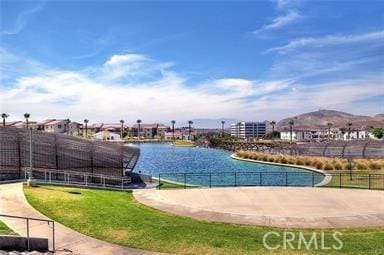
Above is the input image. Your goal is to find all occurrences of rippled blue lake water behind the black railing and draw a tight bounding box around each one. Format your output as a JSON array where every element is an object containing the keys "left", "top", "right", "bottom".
[{"left": 135, "top": 143, "right": 323, "bottom": 186}]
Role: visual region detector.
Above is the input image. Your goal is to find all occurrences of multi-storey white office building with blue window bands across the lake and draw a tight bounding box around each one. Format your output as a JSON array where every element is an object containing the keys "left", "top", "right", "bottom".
[{"left": 231, "top": 122, "right": 267, "bottom": 139}]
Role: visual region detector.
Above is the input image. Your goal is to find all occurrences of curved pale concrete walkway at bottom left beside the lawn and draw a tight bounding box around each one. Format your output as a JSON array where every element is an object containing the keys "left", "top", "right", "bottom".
[{"left": 0, "top": 183, "right": 160, "bottom": 255}]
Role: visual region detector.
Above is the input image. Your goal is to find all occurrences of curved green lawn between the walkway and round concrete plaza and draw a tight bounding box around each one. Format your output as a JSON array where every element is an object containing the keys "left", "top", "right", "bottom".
[{"left": 24, "top": 186, "right": 384, "bottom": 255}]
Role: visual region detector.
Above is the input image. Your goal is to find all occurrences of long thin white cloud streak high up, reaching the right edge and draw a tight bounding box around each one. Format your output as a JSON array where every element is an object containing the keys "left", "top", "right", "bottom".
[{"left": 266, "top": 30, "right": 384, "bottom": 53}]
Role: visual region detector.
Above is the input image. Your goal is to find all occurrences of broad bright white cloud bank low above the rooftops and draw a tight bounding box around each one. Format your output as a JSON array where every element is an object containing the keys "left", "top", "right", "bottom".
[{"left": 0, "top": 49, "right": 384, "bottom": 123}]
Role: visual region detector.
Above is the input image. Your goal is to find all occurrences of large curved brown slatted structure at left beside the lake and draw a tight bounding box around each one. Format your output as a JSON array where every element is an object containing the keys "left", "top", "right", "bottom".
[{"left": 0, "top": 127, "right": 140, "bottom": 180}]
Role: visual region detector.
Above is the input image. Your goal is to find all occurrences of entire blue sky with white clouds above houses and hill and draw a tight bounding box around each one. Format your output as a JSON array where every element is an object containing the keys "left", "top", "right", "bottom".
[{"left": 0, "top": 0, "right": 384, "bottom": 122}]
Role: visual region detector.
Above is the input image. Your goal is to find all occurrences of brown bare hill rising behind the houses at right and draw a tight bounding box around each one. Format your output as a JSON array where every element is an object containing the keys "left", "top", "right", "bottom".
[{"left": 276, "top": 110, "right": 384, "bottom": 130}]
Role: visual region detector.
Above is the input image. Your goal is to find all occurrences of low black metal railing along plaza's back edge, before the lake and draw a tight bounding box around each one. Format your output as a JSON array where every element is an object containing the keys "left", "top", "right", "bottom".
[{"left": 157, "top": 171, "right": 384, "bottom": 190}]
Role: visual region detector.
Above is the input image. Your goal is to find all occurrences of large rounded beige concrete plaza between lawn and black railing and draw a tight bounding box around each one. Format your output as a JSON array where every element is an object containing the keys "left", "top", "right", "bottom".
[{"left": 133, "top": 187, "right": 384, "bottom": 228}]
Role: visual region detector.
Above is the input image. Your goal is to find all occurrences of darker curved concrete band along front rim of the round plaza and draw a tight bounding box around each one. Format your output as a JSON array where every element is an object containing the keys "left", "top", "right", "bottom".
[{"left": 133, "top": 187, "right": 384, "bottom": 229}]
